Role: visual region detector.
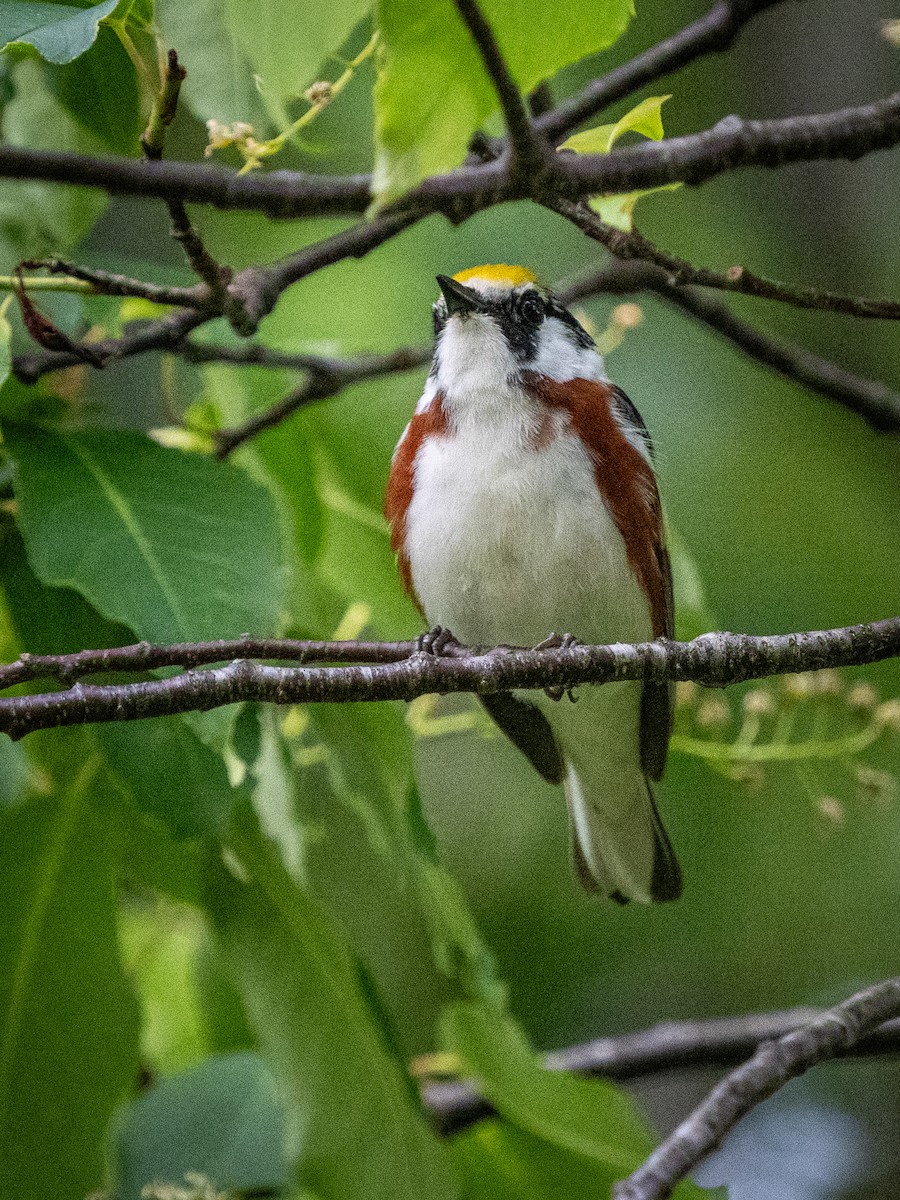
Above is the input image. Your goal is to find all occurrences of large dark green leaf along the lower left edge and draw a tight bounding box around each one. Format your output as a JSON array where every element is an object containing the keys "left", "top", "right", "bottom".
[{"left": 0, "top": 787, "right": 138, "bottom": 1200}]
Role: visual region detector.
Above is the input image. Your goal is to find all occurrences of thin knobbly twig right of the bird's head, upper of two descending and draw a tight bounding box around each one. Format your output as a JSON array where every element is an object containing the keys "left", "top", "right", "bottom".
[{"left": 547, "top": 200, "right": 900, "bottom": 320}]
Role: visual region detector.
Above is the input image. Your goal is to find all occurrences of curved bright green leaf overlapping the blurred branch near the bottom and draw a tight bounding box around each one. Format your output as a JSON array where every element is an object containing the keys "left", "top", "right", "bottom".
[{"left": 440, "top": 1004, "right": 704, "bottom": 1200}]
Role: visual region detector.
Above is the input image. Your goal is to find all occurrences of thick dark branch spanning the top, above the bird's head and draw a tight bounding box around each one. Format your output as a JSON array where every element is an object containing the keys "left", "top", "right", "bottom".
[{"left": 0, "top": 94, "right": 900, "bottom": 220}]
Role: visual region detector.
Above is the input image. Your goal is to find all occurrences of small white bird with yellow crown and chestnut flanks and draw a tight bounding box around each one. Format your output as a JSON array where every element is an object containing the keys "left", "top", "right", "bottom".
[{"left": 384, "top": 264, "right": 682, "bottom": 904}]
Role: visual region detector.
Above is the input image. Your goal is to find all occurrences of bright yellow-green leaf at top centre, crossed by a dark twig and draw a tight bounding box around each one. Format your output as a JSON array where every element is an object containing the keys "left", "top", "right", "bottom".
[{"left": 374, "top": 0, "right": 634, "bottom": 204}]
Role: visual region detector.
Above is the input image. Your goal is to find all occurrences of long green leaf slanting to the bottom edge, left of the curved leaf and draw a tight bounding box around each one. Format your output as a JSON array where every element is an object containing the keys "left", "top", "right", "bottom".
[{"left": 209, "top": 809, "right": 456, "bottom": 1200}]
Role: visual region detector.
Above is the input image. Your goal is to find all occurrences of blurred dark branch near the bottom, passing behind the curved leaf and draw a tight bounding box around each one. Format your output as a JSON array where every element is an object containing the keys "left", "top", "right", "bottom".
[{"left": 421, "top": 1008, "right": 900, "bottom": 1136}]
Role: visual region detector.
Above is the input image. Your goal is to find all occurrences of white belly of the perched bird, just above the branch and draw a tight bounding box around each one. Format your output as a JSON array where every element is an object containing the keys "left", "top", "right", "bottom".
[{"left": 407, "top": 428, "right": 653, "bottom": 646}]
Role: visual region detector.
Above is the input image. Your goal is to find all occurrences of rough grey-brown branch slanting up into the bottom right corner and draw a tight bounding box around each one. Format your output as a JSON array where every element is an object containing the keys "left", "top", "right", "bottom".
[{"left": 613, "top": 978, "right": 900, "bottom": 1200}]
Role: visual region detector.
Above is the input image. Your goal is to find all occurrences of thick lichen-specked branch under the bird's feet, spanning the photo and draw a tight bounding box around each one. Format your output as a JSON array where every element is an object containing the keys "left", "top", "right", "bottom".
[{"left": 0, "top": 617, "right": 900, "bottom": 738}]
